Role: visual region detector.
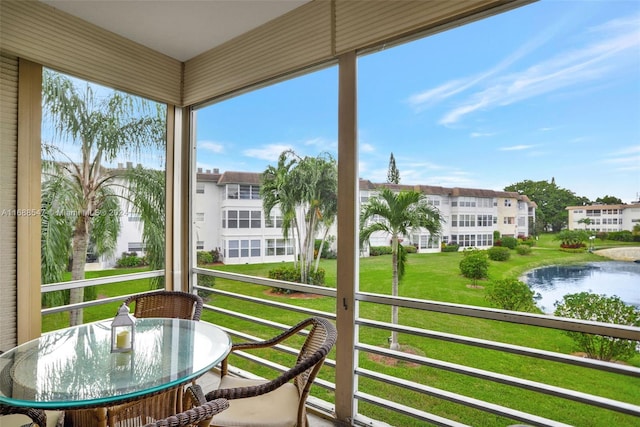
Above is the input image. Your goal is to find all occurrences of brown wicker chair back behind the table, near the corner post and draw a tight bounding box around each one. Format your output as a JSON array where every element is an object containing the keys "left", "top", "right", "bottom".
[{"left": 124, "top": 291, "right": 202, "bottom": 320}]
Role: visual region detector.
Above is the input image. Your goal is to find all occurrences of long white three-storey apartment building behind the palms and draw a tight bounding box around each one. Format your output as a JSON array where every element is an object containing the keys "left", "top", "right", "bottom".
[{"left": 111, "top": 169, "right": 536, "bottom": 264}]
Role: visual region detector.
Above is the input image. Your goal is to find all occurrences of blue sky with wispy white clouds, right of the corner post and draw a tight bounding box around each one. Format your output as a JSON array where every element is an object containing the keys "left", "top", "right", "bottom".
[{"left": 197, "top": 0, "right": 640, "bottom": 202}]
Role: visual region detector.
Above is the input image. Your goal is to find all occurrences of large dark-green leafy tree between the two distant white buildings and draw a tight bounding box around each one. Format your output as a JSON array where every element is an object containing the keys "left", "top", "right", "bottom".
[{"left": 504, "top": 178, "right": 589, "bottom": 236}]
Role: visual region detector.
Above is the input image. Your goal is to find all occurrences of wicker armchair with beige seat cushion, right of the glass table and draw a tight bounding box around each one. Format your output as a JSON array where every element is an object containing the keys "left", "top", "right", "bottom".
[{"left": 192, "top": 317, "right": 337, "bottom": 427}]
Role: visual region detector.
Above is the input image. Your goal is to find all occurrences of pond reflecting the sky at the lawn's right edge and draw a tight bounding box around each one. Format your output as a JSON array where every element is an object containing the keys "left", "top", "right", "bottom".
[{"left": 521, "top": 261, "right": 640, "bottom": 314}]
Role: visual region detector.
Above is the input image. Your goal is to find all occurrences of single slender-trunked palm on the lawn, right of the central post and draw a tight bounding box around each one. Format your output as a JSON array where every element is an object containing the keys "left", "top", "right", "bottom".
[{"left": 360, "top": 187, "right": 442, "bottom": 350}]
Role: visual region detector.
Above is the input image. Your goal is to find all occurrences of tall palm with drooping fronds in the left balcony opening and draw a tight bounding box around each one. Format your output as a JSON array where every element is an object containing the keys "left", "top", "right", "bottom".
[{"left": 41, "top": 70, "right": 166, "bottom": 325}]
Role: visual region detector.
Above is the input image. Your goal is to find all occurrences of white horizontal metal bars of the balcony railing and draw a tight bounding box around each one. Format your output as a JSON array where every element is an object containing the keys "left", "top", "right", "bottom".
[{"left": 43, "top": 268, "right": 640, "bottom": 426}]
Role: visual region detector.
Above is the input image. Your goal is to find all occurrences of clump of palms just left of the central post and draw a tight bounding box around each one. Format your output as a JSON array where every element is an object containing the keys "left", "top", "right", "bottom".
[{"left": 260, "top": 150, "right": 338, "bottom": 283}]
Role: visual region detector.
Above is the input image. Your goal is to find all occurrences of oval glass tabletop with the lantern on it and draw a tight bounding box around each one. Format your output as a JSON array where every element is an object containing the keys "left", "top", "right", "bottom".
[{"left": 0, "top": 318, "right": 231, "bottom": 420}]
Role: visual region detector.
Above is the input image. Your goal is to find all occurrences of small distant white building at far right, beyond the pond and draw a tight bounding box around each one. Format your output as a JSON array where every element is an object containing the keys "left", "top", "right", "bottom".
[{"left": 566, "top": 203, "right": 640, "bottom": 232}]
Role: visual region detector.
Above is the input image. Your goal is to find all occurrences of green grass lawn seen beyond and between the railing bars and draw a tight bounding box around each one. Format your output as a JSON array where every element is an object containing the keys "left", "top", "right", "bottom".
[{"left": 43, "top": 235, "right": 640, "bottom": 426}]
